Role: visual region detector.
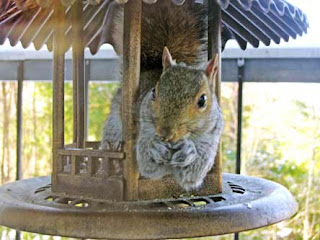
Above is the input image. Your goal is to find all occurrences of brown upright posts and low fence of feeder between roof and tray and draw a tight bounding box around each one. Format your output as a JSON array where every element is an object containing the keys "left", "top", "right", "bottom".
[{"left": 52, "top": 0, "right": 222, "bottom": 201}]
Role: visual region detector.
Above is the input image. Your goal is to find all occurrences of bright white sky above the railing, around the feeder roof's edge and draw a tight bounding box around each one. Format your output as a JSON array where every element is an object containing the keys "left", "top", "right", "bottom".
[{"left": 0, "top": 0, "right": 320, "bottom": 51}]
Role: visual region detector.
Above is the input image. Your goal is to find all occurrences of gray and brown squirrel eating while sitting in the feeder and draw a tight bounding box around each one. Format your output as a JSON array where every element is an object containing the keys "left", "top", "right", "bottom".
[{"left": 101, "top": 0, "right": 223, "bottom": 191}]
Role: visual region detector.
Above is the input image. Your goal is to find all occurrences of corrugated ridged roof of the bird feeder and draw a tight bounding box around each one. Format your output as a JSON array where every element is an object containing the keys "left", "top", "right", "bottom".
[{"left": 0, "top": 0, "right": 309, "bottom": 54}]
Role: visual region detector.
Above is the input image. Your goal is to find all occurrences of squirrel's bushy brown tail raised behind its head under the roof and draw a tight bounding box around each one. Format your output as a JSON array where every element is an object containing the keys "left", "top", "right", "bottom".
[{"left": 113, "top": 0, "right": 207, "bottom": 70}]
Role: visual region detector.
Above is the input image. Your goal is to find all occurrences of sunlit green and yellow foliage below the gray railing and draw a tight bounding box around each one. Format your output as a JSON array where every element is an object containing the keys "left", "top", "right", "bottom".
[{"left": 0, "top": 82, "right": 320, "bottom": 240}]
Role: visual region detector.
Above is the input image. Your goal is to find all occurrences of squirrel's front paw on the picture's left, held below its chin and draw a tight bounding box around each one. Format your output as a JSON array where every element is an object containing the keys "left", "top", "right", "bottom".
[{"left": 149, "top": 136, "right": 171, "bottom": 164}]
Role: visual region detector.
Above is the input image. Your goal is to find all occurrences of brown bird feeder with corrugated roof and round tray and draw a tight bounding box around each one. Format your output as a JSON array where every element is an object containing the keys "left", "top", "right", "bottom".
[{"left": 0, "top": 0, "right": 308, "bottom": 239}]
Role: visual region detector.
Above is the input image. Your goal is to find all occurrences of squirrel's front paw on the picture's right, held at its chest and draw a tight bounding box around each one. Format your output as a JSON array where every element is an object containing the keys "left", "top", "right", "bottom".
[{"left": 170, "top": 139, "right": 197, "bottom": 167}]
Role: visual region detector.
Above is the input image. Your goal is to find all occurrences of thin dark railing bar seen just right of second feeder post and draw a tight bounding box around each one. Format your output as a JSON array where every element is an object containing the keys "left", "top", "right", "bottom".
[{"left": 84, "top": 60, "right": 91, "bottom": 141}]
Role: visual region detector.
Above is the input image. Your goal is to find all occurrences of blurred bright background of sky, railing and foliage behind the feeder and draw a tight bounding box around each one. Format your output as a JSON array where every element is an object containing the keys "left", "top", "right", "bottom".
[{"left": 0, "top": 0, "right": 320, "bottom": 240}]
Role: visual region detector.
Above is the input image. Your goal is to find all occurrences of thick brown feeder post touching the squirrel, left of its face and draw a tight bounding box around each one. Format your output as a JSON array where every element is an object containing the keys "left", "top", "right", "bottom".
[{"left": 122, "top": 0, "right": 142, "bottom": 200}]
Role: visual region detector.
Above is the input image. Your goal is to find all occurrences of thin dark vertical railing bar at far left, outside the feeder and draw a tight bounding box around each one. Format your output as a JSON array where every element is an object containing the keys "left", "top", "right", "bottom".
[{"left": 16, "top": 61, "right": 24, "bottom": 240}]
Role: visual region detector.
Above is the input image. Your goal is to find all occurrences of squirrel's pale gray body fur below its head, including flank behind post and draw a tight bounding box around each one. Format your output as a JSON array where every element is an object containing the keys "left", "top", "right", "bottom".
[{"left": 101, "top": 71, "right": 223, "bottom": 191}]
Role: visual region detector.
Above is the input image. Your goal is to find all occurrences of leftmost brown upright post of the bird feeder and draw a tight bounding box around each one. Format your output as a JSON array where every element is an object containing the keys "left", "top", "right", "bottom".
[{"left": 52, "top": 1, "right": 65, "bottom": 190}]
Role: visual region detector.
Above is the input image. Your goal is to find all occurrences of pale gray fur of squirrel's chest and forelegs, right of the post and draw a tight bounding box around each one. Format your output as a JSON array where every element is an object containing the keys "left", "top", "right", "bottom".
[{"left": 137, "top": 87, "right": 223, "bottom": 191}]
